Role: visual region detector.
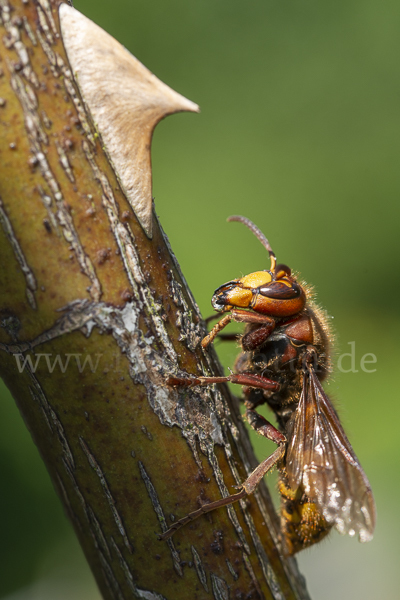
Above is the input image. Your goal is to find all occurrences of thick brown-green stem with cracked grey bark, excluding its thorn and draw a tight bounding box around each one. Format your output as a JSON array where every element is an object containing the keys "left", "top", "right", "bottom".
[{"left": 0, "top": 0, "right": 308, "bottom": 600}]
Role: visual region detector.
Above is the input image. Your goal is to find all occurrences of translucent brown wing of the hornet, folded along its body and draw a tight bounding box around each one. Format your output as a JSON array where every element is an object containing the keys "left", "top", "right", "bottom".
[{"left": 286, "top": 366, "right": 375, "bottom": 542}]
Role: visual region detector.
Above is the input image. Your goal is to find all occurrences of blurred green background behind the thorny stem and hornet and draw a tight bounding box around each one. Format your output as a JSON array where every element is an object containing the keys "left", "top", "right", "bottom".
[{"left": 0, "top": 0, "right": 400, "bottom": 600}]
